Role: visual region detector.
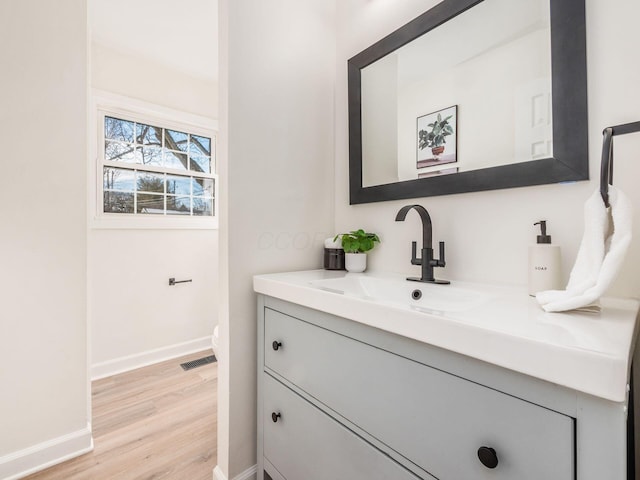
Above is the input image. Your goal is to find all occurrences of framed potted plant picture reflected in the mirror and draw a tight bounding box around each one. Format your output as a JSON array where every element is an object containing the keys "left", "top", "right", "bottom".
[{"left": 416, "top": 105, "right": 458, "bottom": 168}]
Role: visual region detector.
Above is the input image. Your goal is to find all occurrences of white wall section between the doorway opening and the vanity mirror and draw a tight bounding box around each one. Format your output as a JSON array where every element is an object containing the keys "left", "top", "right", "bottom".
[{"left": 217, "top": 0, "right": 335, "bottom": 479}]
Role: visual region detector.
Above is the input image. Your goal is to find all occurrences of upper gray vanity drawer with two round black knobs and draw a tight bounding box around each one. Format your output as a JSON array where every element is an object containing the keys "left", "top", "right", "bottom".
[{"left": 264, "top": 308, "right": 575, "bottom": 480}]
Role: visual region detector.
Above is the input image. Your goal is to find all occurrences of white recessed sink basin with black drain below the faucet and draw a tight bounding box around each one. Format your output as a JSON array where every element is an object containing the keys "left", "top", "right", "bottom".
[{"left": 309, "top": 274, "right": 491, "bottom": 313}]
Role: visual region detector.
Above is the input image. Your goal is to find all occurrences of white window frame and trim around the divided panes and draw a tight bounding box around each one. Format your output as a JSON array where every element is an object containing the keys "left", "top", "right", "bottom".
[{"left": 88, "top": 89, "right": 220, "bottom": 229}]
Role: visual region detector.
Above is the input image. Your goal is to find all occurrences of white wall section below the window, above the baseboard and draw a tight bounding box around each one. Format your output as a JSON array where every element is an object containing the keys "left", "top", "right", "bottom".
[{"left": 89, "top": 229, "right": 218, "bottom": 370}]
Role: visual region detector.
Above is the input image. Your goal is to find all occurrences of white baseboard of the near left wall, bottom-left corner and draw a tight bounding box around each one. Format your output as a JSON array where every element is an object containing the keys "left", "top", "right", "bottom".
[{"left": 0, "top": 425, "right": 93, "bottom": 480}]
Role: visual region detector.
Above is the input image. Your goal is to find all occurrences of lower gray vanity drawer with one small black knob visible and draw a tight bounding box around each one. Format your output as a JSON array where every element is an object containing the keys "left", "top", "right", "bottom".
[{"left": 262, "top": 373, "right": 424, "bottom": 480}]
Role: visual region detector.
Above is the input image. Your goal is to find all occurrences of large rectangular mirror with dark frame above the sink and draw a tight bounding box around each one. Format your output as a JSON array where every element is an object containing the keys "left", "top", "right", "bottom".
[{"left": 348, "top": 0, "right": 589, "bottom": 204}]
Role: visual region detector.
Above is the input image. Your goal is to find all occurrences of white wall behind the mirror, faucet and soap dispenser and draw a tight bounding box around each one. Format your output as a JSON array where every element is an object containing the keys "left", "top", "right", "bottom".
[{"left": 335, "top": 0, "right": 640, "bottom": 296}]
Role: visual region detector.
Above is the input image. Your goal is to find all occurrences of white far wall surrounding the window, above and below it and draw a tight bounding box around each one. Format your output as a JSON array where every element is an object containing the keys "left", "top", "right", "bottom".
[{"left": 88, "top": 43, "right": 218, "bottom": 377}]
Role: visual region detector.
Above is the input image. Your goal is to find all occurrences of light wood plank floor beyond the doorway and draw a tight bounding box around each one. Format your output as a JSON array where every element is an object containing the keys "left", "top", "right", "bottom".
[{"left": 26, "top": 351, "right": 218, "bottom": 480}]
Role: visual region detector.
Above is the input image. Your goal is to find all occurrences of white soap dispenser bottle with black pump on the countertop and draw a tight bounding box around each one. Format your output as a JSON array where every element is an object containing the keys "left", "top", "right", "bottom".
[{"left": 529, "top": 220, "right": 562, "bottom": 296}]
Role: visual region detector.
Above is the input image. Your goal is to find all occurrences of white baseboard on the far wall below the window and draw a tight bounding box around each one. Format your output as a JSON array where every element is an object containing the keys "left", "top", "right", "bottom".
[{"left": 91, "top": 336, "right": 211, "bottom": 381}]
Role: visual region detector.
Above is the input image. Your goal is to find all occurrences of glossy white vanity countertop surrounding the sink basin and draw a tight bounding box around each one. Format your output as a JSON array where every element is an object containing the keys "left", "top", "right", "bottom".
[{"left": 253, "top": 270, "right": 640, "bottom": 402}]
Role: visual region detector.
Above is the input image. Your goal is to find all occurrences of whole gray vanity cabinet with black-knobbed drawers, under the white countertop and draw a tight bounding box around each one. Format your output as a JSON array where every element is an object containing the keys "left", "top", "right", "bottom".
[{"left": 258, "top": 296, "right": 624, "bottom": 480}]
